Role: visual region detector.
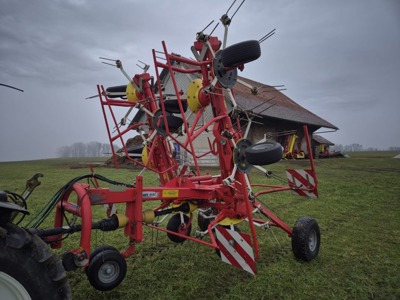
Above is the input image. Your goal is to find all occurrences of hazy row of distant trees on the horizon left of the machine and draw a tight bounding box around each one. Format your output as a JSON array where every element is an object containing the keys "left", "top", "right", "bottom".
[{"left": 57, "top": 142, "right": 117, "bottom": 157}]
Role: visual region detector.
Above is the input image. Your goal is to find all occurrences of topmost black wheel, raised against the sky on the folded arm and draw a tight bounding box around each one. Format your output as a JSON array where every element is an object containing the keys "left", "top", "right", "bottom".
[{"left": 221, "top": 40, "right": 261, "bottom": 67}]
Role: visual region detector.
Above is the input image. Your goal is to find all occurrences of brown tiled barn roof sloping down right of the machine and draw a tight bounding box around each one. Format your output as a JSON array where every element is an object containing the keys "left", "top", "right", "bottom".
[{"left": 232, "top": 77, "right": 338, "bottom": 130}]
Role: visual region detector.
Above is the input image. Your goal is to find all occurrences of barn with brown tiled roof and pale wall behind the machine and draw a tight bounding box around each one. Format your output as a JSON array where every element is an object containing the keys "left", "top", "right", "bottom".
[{"left": 132, "top": 59, "right": 338, "bottom": 165}]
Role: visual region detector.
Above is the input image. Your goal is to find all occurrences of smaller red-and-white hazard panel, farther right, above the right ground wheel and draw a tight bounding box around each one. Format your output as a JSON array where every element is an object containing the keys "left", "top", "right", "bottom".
[{"left": 286, "top": 169, "right": 318, "bottom": 198}]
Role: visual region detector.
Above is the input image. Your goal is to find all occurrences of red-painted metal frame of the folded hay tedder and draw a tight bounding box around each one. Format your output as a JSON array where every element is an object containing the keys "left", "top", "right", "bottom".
[{"left": 47, "top": 33, "right": 316, "bottom": 272}]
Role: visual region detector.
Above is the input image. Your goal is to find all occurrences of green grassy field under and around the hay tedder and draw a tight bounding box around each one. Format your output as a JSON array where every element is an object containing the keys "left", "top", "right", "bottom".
[{"left": 0, "top": 152, "right": 400, "bottom": 300}]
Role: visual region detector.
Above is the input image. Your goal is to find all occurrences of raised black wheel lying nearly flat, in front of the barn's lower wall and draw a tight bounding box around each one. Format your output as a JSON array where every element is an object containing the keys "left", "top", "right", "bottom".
[{"left": 246, "top": 141, "right": 282, "bottom": 166}]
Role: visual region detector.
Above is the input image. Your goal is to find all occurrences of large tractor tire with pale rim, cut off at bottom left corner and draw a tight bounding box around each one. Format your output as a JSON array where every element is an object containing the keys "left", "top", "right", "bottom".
[{"left": 0, "top": 223, "right": 72, "bottom": 300}]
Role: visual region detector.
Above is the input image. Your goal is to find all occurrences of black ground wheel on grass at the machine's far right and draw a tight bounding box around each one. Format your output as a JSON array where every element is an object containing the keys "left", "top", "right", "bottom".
[{"left": 292, "top": 217, "right": 321, "bottom": 261}]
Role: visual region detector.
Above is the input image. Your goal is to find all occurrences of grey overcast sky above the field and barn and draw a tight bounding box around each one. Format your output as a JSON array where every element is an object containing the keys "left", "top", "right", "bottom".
[{"left": 0, "top": 0, "right": 400, "bottom": 161}]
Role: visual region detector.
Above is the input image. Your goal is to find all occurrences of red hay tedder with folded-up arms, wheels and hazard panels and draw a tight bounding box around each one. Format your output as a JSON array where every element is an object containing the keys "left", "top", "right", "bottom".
[{"left": 0, "top": 2, "right": 320, "bottom": 298}]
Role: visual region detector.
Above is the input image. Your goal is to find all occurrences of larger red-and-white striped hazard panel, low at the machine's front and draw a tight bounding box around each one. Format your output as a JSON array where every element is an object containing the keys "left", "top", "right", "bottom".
[{"left": 215, "top": 226, "right": 256, "bottom": 275}]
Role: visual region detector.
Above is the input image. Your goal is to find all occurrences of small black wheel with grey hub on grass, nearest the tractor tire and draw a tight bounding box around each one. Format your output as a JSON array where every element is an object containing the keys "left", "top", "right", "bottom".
[{"left": 87, "top": 246, "right": 126, "bottom": 291}]
